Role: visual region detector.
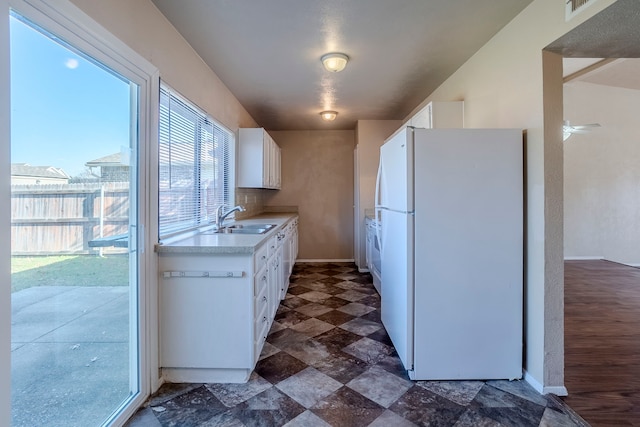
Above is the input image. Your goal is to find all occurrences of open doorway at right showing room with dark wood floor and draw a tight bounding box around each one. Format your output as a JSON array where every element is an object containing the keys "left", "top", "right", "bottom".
[{"left": 563, "top": 58, "right": 640, "bottom": 426}]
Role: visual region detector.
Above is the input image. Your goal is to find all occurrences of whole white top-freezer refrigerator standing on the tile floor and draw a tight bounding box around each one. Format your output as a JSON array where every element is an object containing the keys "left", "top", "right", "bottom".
[{"left": 376, "top": 127, "right": 523, "bottom": 380}]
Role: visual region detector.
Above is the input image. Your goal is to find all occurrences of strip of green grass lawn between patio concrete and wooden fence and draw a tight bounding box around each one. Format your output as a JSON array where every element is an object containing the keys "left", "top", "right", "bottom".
[{"left": 11, "top": 255, "right": 129, "bottom": 292}]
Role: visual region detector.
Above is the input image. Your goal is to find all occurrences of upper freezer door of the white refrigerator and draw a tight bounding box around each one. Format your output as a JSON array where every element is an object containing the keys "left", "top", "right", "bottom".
[{"left": 377, "top": 128, "right": 413, "bottom": 212}]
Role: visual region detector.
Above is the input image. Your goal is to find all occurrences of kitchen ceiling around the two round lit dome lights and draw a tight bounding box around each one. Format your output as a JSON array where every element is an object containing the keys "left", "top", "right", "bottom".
[{"left": 152, "top": 0, "right": 531, "bottom": 130}]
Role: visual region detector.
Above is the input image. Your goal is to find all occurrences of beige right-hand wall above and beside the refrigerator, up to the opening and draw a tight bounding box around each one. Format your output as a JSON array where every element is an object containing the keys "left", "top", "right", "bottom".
[{"left": 402, "top": 0, "right": 613, "bottom": 393}]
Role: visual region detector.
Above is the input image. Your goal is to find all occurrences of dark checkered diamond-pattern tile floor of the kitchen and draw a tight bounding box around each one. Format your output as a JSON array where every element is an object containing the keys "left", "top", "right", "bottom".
[{"left": 128, "top": 263, "right": 584, "bottom": 427}]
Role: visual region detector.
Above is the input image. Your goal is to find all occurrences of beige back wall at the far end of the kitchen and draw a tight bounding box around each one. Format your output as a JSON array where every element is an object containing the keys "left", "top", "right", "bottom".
[{"left": 264, "top": 130, "right": 355, "bottom": 260}]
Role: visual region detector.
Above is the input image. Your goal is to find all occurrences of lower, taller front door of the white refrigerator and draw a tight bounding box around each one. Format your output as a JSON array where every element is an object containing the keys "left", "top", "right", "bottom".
[{"left": 380, "top": 210, "right": 414, "bottom": 370}]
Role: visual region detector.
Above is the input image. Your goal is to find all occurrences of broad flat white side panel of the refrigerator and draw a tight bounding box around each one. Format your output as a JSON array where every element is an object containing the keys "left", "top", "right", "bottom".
[{"left": 412, "top": 129, "right": 523, "bottom": 380}]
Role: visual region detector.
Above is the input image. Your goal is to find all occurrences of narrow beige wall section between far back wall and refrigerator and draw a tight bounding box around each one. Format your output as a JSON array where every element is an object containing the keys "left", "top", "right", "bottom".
[{"left": 354, "top": 120, "right": 402, "bottom": 268}]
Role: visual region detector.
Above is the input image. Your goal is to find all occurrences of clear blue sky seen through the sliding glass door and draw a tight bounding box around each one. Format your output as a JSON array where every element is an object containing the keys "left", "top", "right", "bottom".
[{"left": 11, "top": 13, "right": 130, "bottom": 176}]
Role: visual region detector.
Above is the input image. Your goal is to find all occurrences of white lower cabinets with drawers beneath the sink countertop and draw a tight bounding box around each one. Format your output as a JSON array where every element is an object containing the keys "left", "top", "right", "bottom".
[{"left": 158, "top": 220, "right": 297, "bottom": 383}]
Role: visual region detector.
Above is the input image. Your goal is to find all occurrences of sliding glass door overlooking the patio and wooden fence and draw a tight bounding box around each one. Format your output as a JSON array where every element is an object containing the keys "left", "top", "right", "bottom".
[{"left": 10, "top": 5, "right": 148, "bottom": 427}]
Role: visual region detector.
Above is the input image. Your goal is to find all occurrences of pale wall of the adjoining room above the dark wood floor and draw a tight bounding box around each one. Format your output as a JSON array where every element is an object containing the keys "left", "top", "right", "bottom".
[{"left": 564, "top": 82, "right": 640, "bottom": 265}]
